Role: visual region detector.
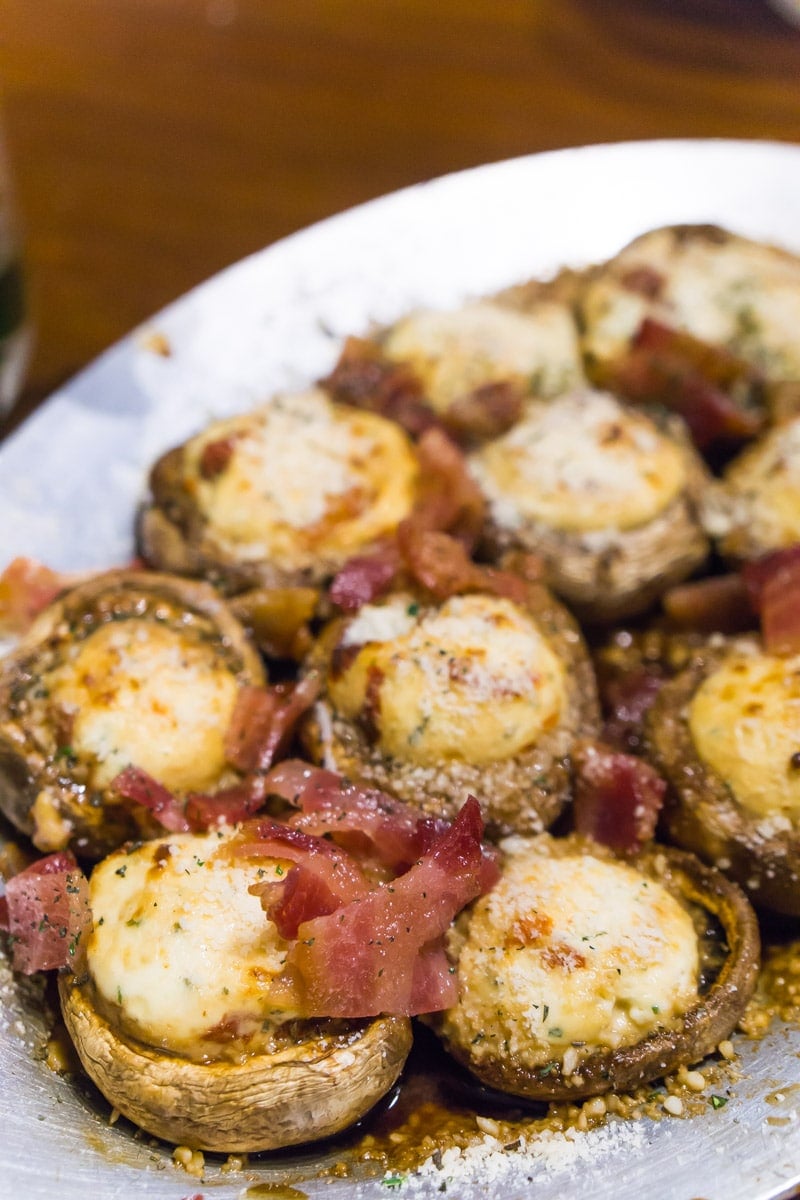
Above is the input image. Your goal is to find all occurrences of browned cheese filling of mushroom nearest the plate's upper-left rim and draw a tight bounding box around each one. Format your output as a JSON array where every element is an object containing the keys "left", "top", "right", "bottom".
[{"left": 185, "top": 390, "right": 417, "bottom": 570}]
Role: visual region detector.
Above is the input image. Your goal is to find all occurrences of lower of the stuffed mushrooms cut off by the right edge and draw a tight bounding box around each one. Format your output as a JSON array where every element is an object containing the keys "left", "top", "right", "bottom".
[{"left": 645, "top": 638, "right": 800, "bottom": 916}]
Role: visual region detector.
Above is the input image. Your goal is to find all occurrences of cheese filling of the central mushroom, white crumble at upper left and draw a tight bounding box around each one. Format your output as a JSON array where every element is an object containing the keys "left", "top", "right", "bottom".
[{"left": 329, "top": 595, "right": 566, "bottom": 764}]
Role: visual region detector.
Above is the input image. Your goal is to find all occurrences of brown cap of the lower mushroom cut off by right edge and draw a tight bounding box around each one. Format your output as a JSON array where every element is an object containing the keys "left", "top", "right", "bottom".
[{"left": 645, "top": 643, "right": 800, "bottom": 916}]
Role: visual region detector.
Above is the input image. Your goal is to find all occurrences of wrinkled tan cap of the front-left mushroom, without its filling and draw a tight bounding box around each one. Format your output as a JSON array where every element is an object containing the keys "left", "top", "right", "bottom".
[{"left": 59, "top": 977, "right": 411, "bottom": 1153}]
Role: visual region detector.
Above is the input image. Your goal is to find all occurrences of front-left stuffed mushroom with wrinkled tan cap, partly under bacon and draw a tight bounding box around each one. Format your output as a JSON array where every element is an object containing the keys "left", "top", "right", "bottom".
[{"left": 59, "top": 830, "right": 411, "bottom": 1152}]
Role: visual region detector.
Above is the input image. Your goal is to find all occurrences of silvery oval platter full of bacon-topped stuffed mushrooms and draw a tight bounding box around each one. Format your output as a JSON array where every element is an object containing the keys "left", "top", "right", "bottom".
[{"left": 0, "top": 142, "right": 800, "bottom": 1200}]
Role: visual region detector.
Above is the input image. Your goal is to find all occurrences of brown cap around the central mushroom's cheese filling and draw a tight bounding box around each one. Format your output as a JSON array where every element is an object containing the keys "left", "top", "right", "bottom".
[{"left": 302, "top": 584, "right": 600, "bottom": 836}]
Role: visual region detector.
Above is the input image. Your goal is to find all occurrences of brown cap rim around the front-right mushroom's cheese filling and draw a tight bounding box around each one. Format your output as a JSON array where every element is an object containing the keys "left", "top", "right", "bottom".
[{"left": 431, "top": 842, "right": 760, "bottom": 1100}]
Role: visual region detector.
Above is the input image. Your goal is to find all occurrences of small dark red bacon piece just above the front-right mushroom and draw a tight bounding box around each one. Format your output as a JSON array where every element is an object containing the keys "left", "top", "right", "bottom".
[{"left": 572, "top": 738, "right": 667, "bottom": 853}]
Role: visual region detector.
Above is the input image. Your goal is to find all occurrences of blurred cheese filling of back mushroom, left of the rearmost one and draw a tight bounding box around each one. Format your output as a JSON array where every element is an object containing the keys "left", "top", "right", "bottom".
[{"left": 383, "top": 301, "right": 583, "bottom": 413}]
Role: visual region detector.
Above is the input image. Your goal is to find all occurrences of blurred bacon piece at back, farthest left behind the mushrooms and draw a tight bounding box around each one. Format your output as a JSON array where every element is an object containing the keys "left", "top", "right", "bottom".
[{"left": 320, "top": 337, "right": 438, "bottom": 438}]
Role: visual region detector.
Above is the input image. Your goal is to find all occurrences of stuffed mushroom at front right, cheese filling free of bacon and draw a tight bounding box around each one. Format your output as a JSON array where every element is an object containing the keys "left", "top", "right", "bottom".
[{"left": 429, "top": 834, "right": 759, "bottom": 1100}]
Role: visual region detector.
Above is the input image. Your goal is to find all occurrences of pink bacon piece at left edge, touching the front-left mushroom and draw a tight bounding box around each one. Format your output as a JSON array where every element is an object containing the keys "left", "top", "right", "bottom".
[{"left": 4, "top": 851, "right": 91, "bottom": 974}]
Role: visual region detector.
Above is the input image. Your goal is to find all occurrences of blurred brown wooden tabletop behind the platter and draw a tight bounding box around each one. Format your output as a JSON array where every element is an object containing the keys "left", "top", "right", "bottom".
[{"left": 0, "top": 0, "right": 800, "bottom": 429}]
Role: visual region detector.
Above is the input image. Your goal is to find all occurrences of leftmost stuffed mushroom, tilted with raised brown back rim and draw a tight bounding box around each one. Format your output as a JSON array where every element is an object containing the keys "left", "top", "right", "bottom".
[{"left": 0, "top": 571, "right": 265, "bottom": 858}]
